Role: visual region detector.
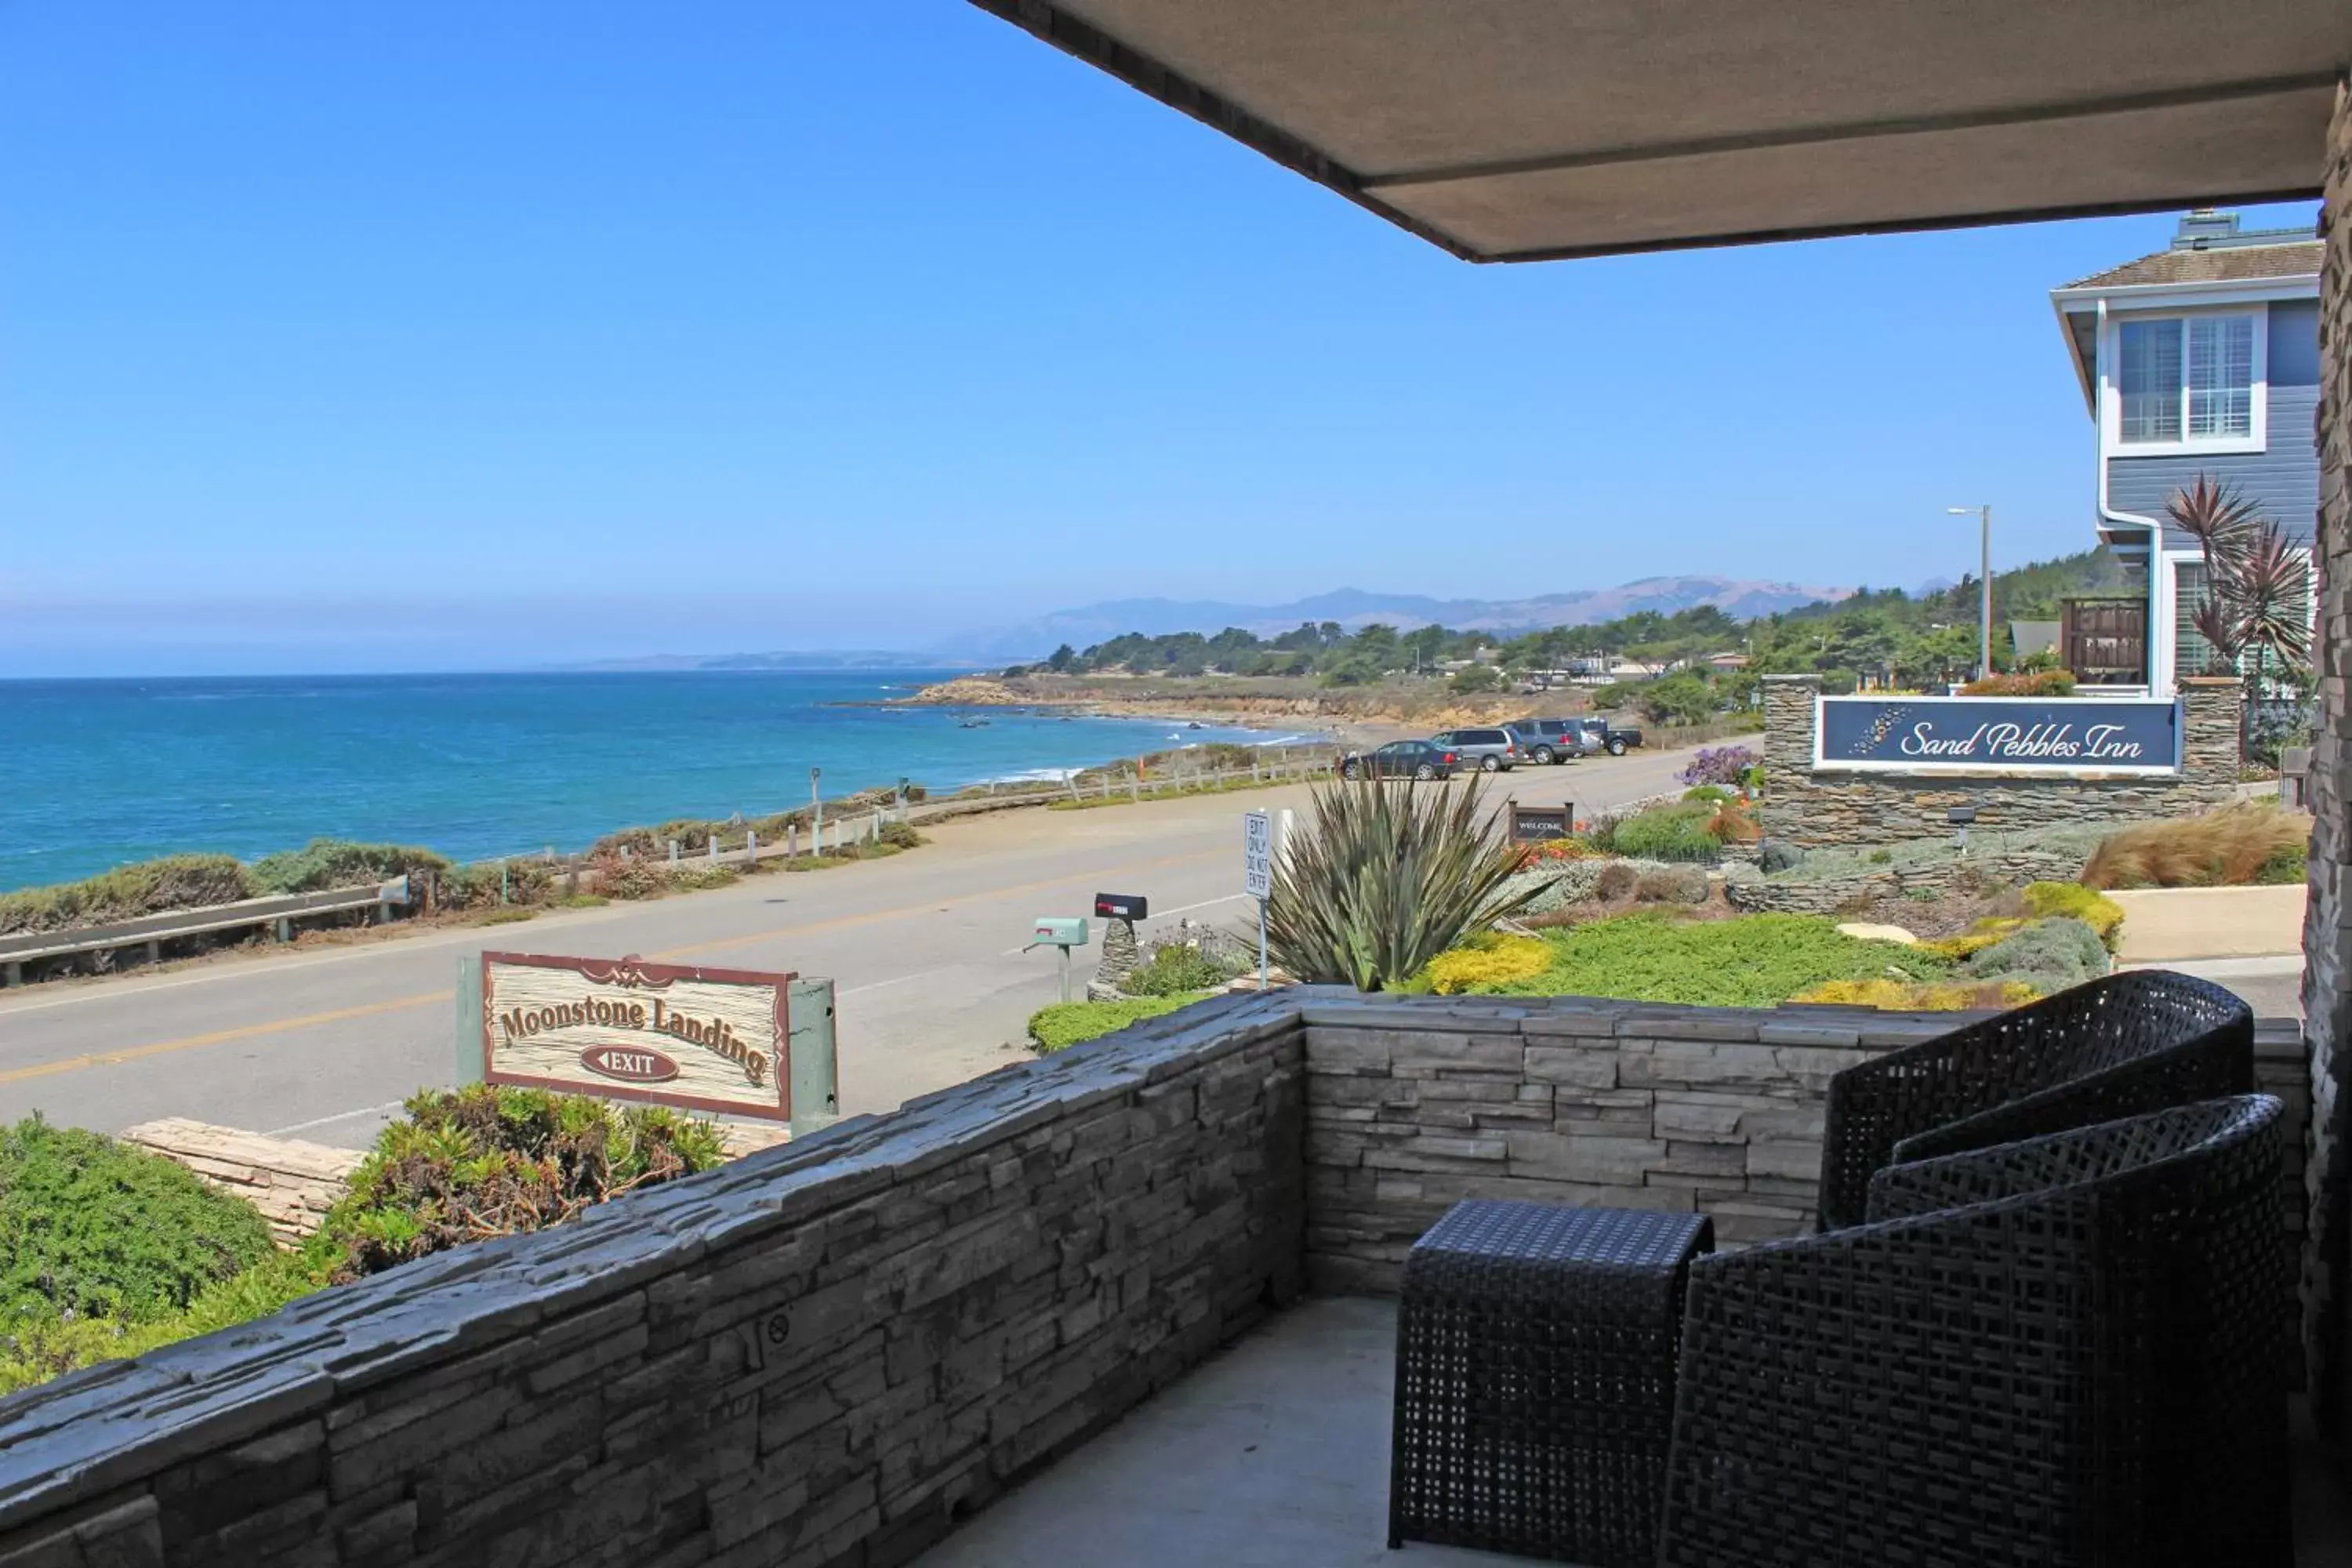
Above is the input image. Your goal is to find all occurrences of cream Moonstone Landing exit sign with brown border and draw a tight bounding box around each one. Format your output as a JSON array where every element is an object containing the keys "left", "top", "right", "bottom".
[{"left": 482, "top": 952, "right": 793, "bottom": 1121}]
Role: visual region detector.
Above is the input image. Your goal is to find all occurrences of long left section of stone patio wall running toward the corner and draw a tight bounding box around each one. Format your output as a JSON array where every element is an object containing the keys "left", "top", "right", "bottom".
[{"left": 0, "top": 996, "right": 1303, "bottom": 1568}]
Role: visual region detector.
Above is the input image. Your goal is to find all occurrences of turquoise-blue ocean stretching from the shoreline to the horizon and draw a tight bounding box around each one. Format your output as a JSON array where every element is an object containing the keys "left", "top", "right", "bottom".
[{"left": 0, "top": 670, "right": 1298, "bottom": 888}]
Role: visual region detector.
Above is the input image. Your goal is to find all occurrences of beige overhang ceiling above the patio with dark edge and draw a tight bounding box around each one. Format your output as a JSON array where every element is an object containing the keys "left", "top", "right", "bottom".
[{"left": 974, "top": 0, "right": 2352, "bottom": 261}]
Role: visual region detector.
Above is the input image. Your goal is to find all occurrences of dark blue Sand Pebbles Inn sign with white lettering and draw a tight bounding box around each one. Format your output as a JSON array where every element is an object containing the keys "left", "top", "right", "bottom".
[{"left": 1813, "top": 696, "right": 2180, "bottom": 774}]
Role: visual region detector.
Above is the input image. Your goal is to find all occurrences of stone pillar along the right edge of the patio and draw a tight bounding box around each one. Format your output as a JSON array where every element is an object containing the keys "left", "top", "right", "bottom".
[{"left": 2303, "top": 85, "right": 2352, "bottom": 1432}]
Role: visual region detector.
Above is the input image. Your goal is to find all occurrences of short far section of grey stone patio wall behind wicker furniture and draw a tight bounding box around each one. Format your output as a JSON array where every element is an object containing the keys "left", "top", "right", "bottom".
[{"left": 1305, "top": 996, "right": 2310, "bottom": 1293}]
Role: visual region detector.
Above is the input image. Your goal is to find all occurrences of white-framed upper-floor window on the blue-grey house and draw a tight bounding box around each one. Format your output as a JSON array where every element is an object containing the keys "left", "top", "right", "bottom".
[{"left": 2114, "top": 310, "right": 2270, "bottom": 452}]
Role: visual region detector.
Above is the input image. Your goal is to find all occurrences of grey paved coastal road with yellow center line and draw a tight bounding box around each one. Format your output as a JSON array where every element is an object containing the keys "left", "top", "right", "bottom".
[{"left": 0, "top": 753, "right": 1686, "bottom": 1147}]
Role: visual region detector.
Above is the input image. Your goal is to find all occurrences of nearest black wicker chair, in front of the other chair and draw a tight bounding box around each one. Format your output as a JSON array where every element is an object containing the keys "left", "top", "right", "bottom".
[{"left": 1658, "top": 1095, "right": 2291, "bottom": 1568}]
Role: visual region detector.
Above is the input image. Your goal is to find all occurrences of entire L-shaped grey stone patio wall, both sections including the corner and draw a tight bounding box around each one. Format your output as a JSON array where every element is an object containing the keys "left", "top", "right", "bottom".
[{"left": 0, "top": 987, "right": 2303, "bottom": 1568}]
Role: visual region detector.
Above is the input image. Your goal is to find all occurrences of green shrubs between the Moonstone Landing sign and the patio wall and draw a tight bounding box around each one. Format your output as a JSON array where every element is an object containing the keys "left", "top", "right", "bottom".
[{"left": 0, "top": 1086, "right": 724, "bottom": 1394}]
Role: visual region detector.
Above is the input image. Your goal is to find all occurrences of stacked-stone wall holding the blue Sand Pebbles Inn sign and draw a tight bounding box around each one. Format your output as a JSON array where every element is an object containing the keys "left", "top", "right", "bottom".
[{"left": 1764, "top": 675, "right": 2239, "bottom": 848}]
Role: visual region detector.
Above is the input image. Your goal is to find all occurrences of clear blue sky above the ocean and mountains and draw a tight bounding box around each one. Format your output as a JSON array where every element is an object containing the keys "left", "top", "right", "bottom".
[{"left": 0, "top": 0, "right": 2312, "bottom": 675}]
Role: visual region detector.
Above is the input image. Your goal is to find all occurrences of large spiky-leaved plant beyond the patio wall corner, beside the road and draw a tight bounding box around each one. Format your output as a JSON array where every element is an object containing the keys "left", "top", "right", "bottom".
[{"left": 1265, "top": 779, "right": 1534, "bottom": 992}]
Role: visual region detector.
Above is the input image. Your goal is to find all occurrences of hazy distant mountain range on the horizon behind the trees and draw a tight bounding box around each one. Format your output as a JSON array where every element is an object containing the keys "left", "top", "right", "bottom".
[{"left": 931, "top": 576, "right": 1853, "bottom": 666}]
